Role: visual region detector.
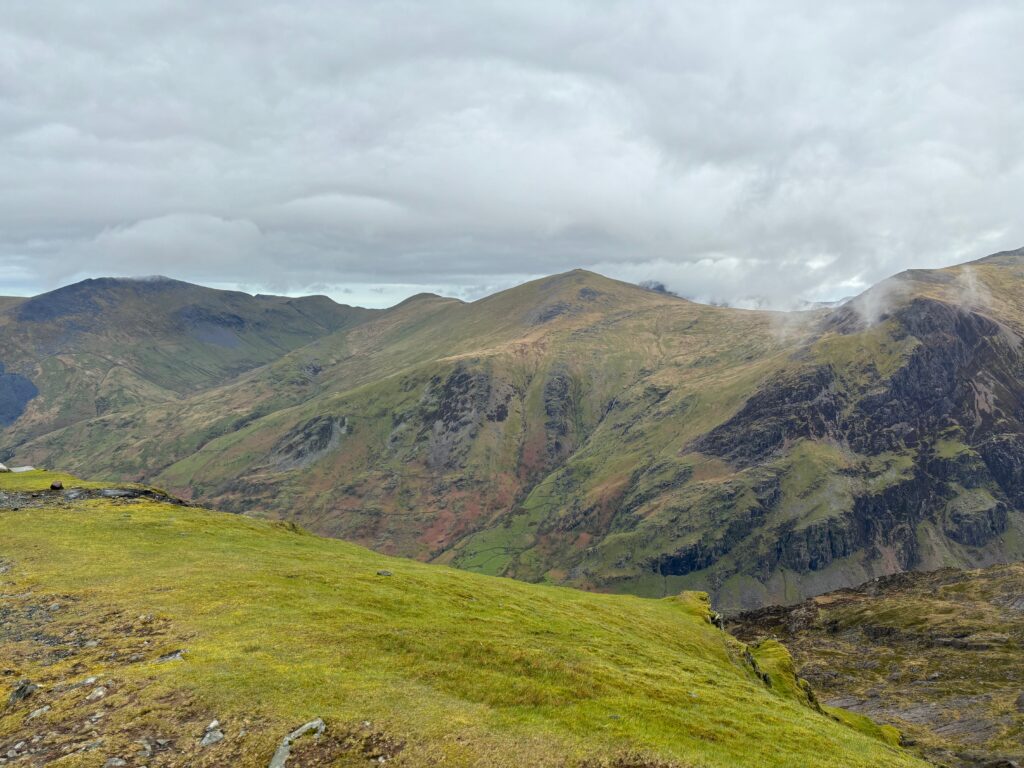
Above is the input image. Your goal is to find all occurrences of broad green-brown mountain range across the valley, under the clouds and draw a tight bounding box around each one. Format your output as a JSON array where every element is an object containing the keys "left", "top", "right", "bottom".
[{"left": 0, "top": 251, "right": 1024, "bottom": 610}]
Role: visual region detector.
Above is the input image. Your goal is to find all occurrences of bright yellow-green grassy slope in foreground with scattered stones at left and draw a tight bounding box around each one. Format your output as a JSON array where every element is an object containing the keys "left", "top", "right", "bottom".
[{"left": 0, "top": 472, "right": 923, "bottom": 768}]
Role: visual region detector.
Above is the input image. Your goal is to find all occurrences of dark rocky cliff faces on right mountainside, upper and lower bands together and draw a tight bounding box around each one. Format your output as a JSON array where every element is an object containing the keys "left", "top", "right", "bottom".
[{"left": 653, "top": 298, "right": 1024, "bottom": 602}]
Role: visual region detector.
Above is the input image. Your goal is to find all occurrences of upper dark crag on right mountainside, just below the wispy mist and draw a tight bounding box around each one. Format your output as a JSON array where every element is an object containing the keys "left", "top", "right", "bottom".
[{"left": 692, "top": 299, "right": 1024, "bottom": 466}]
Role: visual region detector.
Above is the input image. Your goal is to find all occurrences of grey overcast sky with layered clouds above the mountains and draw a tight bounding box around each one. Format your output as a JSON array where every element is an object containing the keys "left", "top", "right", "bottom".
[{"left": 0, "top": 0, "right": 1024, "bottom": 306}]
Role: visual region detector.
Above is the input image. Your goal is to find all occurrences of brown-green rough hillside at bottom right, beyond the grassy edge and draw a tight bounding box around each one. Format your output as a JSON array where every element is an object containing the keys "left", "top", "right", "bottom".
[{"left": 729, "top": 563, "right": 1024, "bottom": 768}]
